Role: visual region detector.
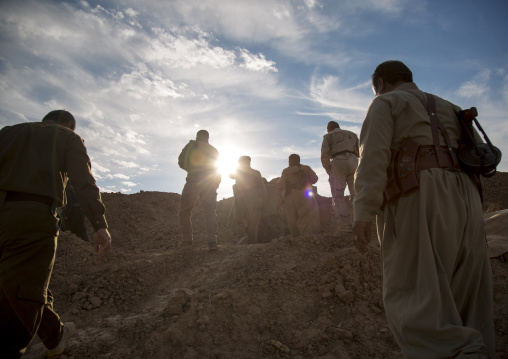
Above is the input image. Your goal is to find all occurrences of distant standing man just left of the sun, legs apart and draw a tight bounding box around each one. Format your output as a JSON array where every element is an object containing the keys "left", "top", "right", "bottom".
[{"left": 178, "top": 130, "right": 221, "bottom": 250}]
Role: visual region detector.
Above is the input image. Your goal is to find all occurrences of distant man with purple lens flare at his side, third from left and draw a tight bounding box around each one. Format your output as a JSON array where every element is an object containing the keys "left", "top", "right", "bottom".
[{"left": 276, "top": 154, "right": 320, "bottom": 238}]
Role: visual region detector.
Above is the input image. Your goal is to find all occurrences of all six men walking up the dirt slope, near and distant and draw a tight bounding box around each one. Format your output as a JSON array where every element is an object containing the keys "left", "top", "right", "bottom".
[{"left": 0, "top": 61, "right": 495, "bottom": 359}]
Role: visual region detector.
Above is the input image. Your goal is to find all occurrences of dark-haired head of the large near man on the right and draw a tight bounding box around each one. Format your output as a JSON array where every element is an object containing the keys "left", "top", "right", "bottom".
[{"left": 372, "top": 60, "right": 413, "bottom": 96}]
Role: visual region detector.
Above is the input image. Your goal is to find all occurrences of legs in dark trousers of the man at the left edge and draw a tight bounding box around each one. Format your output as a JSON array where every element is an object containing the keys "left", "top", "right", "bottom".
[{"left": 0, "top": 202, "right": 61, "bottom": 357}]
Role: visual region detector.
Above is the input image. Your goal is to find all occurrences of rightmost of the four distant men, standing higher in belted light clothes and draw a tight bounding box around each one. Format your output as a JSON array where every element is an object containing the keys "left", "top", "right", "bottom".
[{"left": 321, "top": 121, "right": 359, "bottom": 234}]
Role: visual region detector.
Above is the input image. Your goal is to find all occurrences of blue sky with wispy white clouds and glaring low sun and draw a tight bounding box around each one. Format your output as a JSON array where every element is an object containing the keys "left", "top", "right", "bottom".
[{"left": 0, "top": 0, "right": 508, "bottom": 198}]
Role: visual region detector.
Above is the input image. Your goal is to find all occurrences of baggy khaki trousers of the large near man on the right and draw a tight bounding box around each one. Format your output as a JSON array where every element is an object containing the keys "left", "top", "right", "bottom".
[{"left": 381, "top": 169, "right": 494, "bottom": 359}]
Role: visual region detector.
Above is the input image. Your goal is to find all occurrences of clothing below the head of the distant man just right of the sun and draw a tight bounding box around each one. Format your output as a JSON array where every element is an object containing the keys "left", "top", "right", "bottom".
[{"left": 231, "top": 166, "right": 266, "bottom": 244}]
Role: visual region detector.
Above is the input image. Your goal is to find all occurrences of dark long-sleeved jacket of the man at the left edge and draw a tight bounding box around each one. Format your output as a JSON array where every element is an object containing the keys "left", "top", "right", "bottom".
[{"left": 0, "top": 122, "right": 107, "bottom": 230}]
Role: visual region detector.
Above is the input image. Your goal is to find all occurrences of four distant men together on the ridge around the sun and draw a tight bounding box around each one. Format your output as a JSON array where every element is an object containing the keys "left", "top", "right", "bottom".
[{"left": 178, "top": 121, "right": 359, "bottom": 250}]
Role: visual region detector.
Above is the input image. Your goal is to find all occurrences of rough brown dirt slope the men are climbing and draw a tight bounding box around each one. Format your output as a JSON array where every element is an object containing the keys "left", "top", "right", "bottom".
[{"left": 25, "top": 173, "right": 508, "bottom": 359}]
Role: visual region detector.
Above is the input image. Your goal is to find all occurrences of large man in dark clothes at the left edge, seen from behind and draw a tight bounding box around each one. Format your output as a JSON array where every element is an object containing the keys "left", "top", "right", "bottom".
[{"left": 0, "top": 110, "right": 111, "bottom": 358}]
